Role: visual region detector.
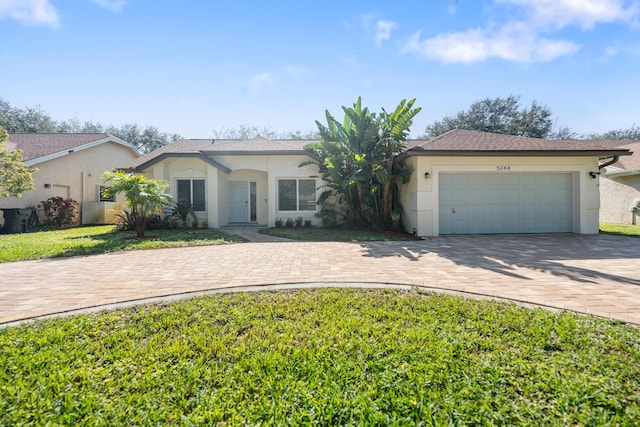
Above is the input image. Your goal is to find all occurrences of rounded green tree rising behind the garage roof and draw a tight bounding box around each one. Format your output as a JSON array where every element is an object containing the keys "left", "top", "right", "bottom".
[{"left": 425, "top": 95, "right": 553, "bottom": 138}]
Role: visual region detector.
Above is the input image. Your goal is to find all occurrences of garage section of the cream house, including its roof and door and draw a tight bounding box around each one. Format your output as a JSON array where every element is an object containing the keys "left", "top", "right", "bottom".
[{"left": 398, "top": 130, "right": 631, "bottom": 236}]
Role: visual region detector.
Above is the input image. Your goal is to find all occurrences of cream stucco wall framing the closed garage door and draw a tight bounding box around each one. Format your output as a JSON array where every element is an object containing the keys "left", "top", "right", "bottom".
[{"left": 401, "top": 156, "right": 600, "bottom": 236}]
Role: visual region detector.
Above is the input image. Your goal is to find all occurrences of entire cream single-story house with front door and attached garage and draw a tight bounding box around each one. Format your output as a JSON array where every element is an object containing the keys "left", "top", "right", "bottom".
[{"left": 125, "top": 130, "right": 630, "bottom": 236}]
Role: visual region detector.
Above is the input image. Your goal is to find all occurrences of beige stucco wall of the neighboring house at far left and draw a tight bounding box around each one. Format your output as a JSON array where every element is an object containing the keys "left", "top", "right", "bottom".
[{"left": 0, "top": 142, "right": 137, "bottom": 224}]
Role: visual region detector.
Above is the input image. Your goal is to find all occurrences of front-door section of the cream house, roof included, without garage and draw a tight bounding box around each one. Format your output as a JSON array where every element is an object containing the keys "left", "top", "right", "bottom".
[{"left": 122, "top": 139, "right": 322, "bottom": 228}]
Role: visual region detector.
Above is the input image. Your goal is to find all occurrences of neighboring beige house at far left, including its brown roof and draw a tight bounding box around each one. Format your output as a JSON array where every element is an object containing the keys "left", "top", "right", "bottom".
[{"left": 0, "top": 133, "right": 140, "bottom": 224}]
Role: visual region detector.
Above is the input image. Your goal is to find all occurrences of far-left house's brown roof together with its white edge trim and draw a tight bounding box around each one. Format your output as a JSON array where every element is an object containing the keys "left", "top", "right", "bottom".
[{"left": 5, "top": 133, "right": 137, "bottom": 164}]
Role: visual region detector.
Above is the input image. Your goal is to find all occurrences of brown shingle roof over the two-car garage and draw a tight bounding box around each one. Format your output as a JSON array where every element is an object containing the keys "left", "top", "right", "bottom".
[{"left": 400, "top": 129, "right": 631, "bottom": 158}]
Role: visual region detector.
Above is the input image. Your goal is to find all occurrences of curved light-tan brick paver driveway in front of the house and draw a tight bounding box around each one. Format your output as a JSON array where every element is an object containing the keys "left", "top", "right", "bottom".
[{"left": 0, "top": 235, "right": 640, "bottom": 324}]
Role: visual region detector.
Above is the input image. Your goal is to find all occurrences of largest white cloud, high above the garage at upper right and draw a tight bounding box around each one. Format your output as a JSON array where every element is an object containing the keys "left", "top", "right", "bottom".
[{"left": 403, "top": 0, "right": 640, "bottom": 63}]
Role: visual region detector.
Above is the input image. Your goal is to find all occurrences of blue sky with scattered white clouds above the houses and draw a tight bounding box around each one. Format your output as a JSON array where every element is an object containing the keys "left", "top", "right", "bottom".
[{"left": 0, "top": 0, "right": 640, "bottom": 138}]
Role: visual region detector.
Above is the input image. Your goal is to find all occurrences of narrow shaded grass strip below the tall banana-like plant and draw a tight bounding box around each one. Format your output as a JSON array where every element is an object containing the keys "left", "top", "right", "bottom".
[{"left": 260, "top": 227, "right": 416, "bottom": 242}]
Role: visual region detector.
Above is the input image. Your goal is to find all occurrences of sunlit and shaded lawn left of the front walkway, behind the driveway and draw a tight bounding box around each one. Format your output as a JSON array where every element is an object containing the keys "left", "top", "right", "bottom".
[{"left": 0, "top": 225, "right": 242, "bottom": 263}]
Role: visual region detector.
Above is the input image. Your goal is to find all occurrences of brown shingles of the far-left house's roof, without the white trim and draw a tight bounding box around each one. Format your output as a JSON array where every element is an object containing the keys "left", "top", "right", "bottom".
[{"left": 9, "top": 133, "right": 133, "bottom": 161}]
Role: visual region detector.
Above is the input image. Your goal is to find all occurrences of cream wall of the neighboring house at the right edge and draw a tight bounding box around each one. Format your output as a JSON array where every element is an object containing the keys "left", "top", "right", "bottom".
[{"left": 600, "top": 175, "right": 640, "bottom": 224}]
